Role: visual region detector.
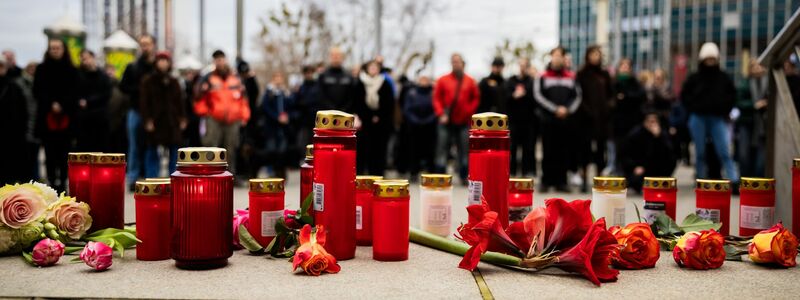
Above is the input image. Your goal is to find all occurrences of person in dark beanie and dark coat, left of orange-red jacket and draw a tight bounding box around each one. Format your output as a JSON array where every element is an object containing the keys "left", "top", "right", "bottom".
[{"left": 139, "top": 51, "right": 187, "bottom": 178}]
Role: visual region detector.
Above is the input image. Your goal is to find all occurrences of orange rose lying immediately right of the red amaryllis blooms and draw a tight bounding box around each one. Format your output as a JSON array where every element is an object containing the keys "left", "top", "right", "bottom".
[{"left": 608, "top": 223, "right": 660, "bottom": 270}]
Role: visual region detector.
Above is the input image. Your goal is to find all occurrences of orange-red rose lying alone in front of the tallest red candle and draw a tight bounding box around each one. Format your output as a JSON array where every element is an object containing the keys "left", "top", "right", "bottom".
[{"left": 292, "top": 224, "right": 341, "bottom": 276}]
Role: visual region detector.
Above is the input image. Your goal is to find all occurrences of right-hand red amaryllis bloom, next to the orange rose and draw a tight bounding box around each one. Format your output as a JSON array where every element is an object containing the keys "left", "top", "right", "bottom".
[{"left": 553, "top": 218, "right": 619, "bottom": 285}]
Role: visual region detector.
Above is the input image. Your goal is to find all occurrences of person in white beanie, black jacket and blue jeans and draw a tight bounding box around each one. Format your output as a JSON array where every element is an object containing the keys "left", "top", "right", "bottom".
[{"left": 680, "top": 43, "right": 739, "bottom": 183}]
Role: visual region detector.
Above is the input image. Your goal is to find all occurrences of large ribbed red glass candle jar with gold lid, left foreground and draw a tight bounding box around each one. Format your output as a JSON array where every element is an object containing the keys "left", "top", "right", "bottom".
[{"left": 171, "top": 147, "right": 233, "bottom": 269}]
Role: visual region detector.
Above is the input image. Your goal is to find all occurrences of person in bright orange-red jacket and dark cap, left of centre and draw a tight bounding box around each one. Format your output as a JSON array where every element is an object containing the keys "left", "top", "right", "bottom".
[{"left": 194, "top": 50, "right": 250, "bottom": 174}]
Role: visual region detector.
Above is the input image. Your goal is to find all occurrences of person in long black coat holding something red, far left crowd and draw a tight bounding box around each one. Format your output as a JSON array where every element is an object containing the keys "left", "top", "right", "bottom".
[{"left": 33, "top": 39, "right": 80, "bottom": 192}]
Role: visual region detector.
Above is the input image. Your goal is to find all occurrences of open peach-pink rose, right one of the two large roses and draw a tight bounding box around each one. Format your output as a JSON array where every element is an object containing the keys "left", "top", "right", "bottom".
[{"left": 47, "top": 197, "right": 92, "bottom": 240}]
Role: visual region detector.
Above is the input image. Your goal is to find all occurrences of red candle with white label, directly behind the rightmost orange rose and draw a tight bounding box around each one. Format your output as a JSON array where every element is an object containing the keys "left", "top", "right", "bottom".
[{"left": 739, "top": 177, "right": 775, "bottom": 236}]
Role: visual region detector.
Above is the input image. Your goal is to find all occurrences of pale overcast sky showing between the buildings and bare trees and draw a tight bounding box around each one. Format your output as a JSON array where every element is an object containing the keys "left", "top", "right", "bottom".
[{"left": 0, "top": 0, "right": 558, "bottom": 77}]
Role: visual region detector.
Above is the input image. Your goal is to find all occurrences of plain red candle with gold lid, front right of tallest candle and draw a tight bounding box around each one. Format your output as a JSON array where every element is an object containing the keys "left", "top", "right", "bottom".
[{"left": 372, "top": 180, "right": 409, "bottom": 261}]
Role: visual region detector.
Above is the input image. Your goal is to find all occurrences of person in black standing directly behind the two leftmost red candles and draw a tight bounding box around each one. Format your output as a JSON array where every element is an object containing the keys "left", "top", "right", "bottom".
[{"left": 75, "top": 50, "right": 112, "bottom": 152}]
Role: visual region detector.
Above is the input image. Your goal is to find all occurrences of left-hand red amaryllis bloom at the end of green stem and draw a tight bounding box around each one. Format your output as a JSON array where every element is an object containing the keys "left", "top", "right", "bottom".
[{"left": 456, "top": 199, "right": 524, "bottom": 271}]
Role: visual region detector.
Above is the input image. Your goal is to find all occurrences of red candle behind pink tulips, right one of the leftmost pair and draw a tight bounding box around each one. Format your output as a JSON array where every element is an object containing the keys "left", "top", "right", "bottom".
[{"left": 86, "top": 153, "right": 125, "bottom": 232}]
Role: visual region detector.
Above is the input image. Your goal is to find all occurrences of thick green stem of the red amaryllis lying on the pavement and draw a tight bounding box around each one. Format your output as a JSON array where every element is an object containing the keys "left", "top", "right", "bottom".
[{"left": 408, "top": 228, "right": 520, "bottom": 267}]
